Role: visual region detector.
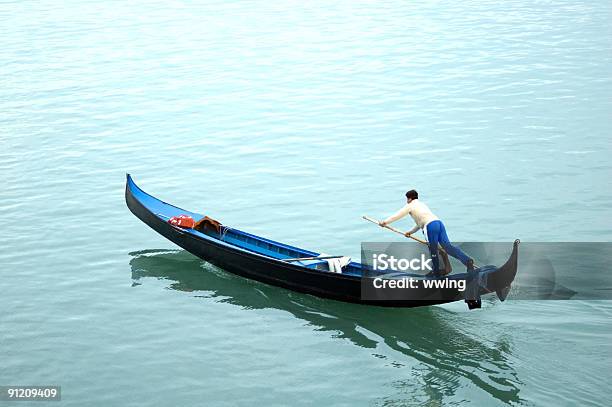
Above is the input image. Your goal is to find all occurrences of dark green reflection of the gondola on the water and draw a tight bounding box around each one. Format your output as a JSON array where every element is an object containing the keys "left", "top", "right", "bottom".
[{"left": 130, "top": 250, "right": 521, "bottom": 405}]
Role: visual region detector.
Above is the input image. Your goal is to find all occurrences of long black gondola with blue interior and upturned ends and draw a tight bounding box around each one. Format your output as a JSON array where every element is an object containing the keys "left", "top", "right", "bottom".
[{"left": 125, "top": 174, "right": 519, "bottom": 309}]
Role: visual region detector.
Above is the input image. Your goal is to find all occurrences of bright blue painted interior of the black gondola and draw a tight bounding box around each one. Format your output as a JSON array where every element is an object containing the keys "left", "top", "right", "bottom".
[{"left": 127, "top": 175, "right": 368, "bottom": 277}]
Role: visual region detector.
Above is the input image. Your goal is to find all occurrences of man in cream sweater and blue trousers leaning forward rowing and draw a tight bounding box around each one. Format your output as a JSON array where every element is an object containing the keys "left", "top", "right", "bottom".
[{"left": 378, "top": 189, "right": 474, "bottom": 276}]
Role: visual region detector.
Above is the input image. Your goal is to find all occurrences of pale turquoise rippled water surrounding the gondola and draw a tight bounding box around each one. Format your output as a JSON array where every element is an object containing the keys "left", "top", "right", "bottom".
[{"left": 0, "top": 0, "right": 612, "bottom": 406}]
